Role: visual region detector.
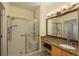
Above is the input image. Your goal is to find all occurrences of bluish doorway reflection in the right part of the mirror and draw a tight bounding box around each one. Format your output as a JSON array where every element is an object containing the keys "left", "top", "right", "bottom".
[{"left": 64, "top": 19, "right": 77, "bottom": 40}]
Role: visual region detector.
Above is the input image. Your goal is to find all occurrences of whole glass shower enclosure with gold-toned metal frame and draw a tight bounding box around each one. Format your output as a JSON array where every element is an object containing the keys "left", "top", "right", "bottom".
[{"left": 8, "top": 17, "right": 39, "bottom": 55}]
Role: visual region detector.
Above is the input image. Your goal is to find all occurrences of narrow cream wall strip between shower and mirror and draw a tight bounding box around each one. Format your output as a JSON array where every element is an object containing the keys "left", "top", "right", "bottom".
[{"left": 40, "top": 5, "right": 47, "bottom": 36}]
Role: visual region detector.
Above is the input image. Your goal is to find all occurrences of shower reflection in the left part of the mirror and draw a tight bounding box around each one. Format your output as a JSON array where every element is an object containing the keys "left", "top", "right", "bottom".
[{"left": 48, "top": 19, "right": 62, "bottom": 37}]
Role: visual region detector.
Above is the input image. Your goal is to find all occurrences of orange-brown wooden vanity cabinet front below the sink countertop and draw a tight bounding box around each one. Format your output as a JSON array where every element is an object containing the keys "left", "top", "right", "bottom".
[{"left": 51, "top": 46, "right": 73, "bottom": 56}]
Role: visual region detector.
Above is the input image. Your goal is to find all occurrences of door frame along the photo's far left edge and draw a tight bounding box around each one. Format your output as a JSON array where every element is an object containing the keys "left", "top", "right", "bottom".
[{"left": 0, "top": 2, "right": 7, "bottom": 56}]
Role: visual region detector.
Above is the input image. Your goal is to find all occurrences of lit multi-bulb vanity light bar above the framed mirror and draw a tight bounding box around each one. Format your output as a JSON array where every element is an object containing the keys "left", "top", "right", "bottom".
[{"left": 47, "top": 2, "right": 78, "bottom": 17}]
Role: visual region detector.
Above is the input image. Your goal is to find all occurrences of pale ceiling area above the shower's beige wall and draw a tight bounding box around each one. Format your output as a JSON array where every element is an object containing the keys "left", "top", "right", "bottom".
[{"left": 10, "top": 2, "right": 53, "bottom": 11}]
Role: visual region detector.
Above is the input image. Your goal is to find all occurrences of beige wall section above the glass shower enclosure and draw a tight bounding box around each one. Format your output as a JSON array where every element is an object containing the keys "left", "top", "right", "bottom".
[{"left": 8, "top": 6, "right": 34, "bottom": 19}]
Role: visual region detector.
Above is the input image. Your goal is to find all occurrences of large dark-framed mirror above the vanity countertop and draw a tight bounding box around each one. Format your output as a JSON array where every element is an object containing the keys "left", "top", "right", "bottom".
[{"left": 46, "top": 10, "right": 79, "bottom": 41}]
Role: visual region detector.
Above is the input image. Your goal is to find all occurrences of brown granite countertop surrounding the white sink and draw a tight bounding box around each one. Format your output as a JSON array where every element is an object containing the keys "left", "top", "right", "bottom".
[{"left": 41, "top": 36, "right": 79, "bottom": 56}]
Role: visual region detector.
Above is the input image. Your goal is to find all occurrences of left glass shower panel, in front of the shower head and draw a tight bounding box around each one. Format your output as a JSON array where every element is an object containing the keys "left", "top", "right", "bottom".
[{"left": 8, "top": 19, "right": 25, "bottom": 55}]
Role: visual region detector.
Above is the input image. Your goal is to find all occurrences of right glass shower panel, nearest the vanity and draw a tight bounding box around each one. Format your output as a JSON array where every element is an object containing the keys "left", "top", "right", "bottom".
[{"left": 26, "top": 21, "right": 39, "bottom": 53}]
